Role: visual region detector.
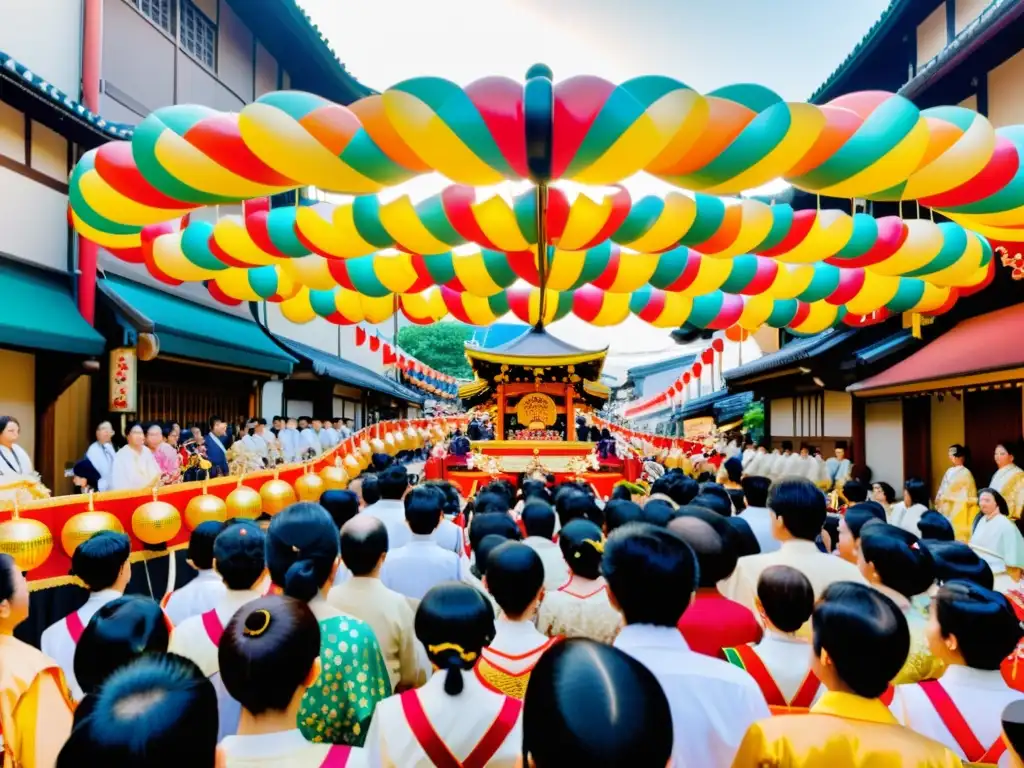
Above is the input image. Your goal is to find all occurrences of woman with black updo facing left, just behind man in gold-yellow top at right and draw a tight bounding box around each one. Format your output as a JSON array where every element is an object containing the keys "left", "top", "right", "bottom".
[{"left": 857, "top": 522, "right": 944, "bottom": 685}]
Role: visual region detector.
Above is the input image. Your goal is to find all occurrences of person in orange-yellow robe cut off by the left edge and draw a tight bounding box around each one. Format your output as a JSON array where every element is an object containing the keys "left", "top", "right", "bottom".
[{"left": 0, "top": 554, "right": 75, "bottom": 768}]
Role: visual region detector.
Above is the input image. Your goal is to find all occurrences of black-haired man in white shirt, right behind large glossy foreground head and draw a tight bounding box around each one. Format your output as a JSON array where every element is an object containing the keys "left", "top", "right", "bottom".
[{"left": 601, "top": 523, "right": 769, "bottom": 768}]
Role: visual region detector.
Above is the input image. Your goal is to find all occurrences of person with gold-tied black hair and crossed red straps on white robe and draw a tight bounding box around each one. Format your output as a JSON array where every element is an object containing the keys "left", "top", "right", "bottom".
[{"left": 367, "top": 583, "right": 522, "bottom": 768}]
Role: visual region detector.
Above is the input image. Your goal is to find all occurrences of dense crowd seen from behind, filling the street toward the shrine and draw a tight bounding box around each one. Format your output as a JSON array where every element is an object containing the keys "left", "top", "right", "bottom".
[{"left": 9, "top": 448, "right": 1024, "bottom": 768}]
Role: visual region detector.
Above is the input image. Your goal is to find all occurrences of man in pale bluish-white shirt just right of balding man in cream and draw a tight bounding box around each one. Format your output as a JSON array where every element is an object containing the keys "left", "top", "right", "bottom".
[{"left": 382, "top": 487, "right": 462, "bottom": 600}]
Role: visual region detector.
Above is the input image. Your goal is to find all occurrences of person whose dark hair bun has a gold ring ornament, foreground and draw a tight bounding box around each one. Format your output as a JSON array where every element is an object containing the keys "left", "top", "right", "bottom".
[{"left": 217, "top": 597, "right": 362, "bottom": 768}]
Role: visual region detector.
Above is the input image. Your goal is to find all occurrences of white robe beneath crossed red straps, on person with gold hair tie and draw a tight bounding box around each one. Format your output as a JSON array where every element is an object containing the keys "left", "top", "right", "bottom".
[{"left": 364, "top": 670, "right": 522, "bottom": 768}]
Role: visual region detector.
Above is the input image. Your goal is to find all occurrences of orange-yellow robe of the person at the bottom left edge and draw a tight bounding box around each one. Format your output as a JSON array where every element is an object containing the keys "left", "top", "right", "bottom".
[{"left": 0, "top": 635, "right": 75, "bottom": 768}]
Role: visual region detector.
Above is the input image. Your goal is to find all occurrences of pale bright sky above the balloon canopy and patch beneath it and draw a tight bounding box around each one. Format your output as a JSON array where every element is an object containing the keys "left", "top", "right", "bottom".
[{"left": 299, "top": 0, "right": 889, "bottom": 365}]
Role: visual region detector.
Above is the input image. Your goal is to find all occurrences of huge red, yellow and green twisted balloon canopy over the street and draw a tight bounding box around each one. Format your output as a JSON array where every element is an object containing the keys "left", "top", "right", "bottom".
[{"left": 64, "top": 67, "right": 1024, "bottom": 333}]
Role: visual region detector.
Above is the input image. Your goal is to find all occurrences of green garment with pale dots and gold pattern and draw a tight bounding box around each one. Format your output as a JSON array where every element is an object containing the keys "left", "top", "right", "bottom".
[{"left": 299, "top": 616, "right": 391, "bottom": 746}]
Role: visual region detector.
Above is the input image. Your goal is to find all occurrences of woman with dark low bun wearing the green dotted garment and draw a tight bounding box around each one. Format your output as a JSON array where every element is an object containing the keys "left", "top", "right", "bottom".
[{"left": 265, "top": 501, "right": 389, "bottom": 746}]
